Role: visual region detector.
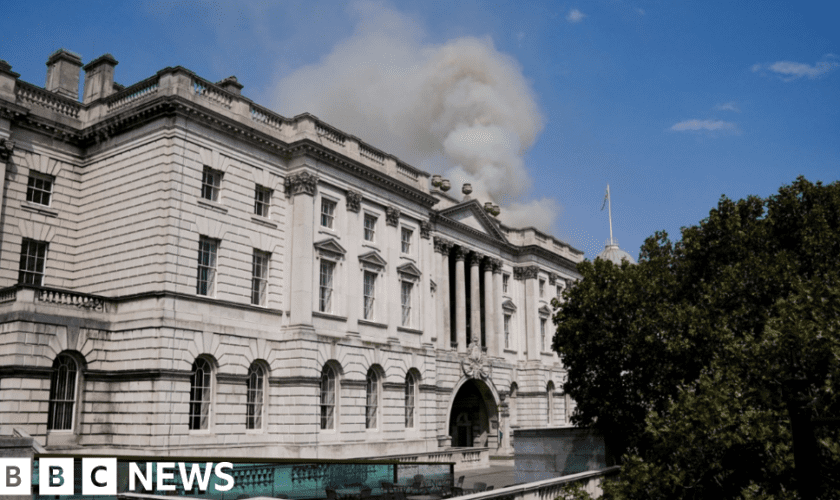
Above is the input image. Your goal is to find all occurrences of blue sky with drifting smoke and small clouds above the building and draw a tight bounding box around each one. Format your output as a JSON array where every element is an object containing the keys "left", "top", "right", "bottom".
[{"left": 0, "top": 0, "right": 840, "bottom": 258}]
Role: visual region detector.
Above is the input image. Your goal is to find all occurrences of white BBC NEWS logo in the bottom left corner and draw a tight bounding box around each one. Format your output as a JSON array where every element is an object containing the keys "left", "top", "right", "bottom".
[{"left": 0, "top": 457, "right": 233, "bottom": 496}]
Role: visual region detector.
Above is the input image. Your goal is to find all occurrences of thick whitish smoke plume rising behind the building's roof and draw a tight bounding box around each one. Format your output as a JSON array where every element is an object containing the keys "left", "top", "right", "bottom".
[{"left": 273, "top": 2, "right": 559, "bottom": 230}]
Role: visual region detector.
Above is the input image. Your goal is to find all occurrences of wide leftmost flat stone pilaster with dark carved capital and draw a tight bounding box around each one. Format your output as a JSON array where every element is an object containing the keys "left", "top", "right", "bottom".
[{"left": 286, "top": 171, "right": 318, "bottom": 326}]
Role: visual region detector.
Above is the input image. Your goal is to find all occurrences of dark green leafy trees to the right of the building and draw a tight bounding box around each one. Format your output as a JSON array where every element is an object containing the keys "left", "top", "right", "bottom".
[{"left": 554, "top": 177, "right": 840, "bottom": 499}]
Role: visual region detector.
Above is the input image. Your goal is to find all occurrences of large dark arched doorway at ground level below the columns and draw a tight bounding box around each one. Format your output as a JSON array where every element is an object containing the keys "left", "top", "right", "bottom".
[{"left": 449, "top": 379, "right": 499, "bottom": 447}]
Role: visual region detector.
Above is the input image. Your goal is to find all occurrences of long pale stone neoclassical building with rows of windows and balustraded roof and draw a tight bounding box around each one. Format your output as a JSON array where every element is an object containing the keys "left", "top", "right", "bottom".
[{"left": 0, "top": 50, "right": 583, "bottom": 458}]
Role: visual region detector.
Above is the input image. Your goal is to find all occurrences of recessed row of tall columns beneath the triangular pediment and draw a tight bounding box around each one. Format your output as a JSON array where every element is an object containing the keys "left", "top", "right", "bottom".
[{"left": 434, "top": 237, "right": 504, "bottom": 356}]
